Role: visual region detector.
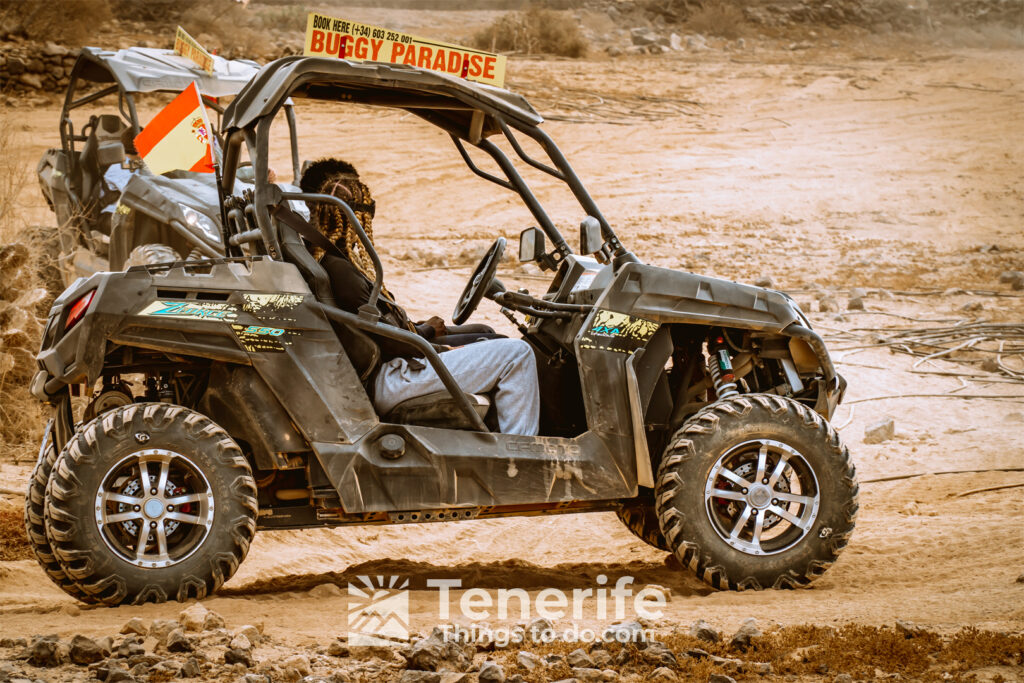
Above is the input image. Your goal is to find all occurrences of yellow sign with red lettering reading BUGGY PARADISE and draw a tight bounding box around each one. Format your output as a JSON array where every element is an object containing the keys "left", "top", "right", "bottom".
[{"left": 304, "top": 12, "right": 507, "bottom": 87}]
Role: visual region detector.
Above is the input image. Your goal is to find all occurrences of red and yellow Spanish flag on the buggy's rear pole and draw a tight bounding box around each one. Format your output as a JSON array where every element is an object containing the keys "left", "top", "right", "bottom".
[{"left": 135, "top": 81, "right": 213, "bottom": 175}]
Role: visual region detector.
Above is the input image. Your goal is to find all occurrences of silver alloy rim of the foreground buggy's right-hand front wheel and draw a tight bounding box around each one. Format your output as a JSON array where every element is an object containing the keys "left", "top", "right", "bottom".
[{"left": 705, "top": 438, "right": 821, "bottom": 556}]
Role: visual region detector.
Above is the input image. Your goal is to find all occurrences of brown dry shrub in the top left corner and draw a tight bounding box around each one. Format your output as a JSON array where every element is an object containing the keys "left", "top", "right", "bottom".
[{"left": 0, "top": 0, "right": 111, "bottom": 45}]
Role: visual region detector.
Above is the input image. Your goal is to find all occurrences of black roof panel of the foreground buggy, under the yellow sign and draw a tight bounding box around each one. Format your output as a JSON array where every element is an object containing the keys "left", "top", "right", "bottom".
[{"left": 223, "top": 56, "right": 544, "bottom": 130}]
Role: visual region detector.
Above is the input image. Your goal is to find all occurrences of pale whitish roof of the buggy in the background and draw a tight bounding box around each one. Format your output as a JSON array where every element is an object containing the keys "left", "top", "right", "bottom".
[{"left": 78, "top": 47, "right": 259, "bottom": 97}]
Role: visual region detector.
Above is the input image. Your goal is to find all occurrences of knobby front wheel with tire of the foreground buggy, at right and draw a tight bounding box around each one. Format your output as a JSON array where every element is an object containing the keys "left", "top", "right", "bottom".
[{"left": 655, "top": 394, "right": 858, "bottom": 591}]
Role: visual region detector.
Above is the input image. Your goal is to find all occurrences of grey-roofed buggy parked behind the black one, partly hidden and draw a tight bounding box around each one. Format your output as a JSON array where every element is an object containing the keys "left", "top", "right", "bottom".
[{"left": 37, "top": 47, "right": 298, "bottom": 286}]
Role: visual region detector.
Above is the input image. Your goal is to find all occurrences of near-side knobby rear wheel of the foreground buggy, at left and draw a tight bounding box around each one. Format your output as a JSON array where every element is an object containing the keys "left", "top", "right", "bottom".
[{"left": 44, "top": 403, "right": 258, "bottom": 605}]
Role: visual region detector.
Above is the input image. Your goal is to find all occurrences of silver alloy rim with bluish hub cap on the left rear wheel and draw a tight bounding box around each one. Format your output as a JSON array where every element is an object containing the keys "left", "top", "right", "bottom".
[{"left": 94, "top": 449, "right": 214, "bottom": 569}]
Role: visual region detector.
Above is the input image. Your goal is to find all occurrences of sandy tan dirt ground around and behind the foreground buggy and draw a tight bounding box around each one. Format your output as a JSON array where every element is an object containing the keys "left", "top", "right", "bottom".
[{"left": 0, "top": 13, "right": 1024, "bottom": 680}]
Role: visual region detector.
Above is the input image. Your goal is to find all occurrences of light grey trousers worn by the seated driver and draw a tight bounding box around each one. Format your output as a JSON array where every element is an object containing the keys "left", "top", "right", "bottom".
[{"left": 374, "top": 339, "right": 541, "bottom": 436}]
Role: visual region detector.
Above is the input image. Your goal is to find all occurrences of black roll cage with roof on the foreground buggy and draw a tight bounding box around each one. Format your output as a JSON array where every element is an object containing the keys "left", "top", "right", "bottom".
[{"left": 221, "top": 56, "right": 635, "bottom": 309}]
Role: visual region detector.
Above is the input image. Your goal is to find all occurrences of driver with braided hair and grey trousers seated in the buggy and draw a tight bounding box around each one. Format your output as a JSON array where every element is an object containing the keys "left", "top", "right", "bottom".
[{"left": 302, "top": 160, "right": 541, "bottom": 436}]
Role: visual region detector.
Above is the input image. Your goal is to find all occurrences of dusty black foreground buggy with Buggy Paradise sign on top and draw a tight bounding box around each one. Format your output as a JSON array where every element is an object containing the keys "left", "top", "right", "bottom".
[{"left": 27, "top": 57, "right": 857, "bottom": 605}]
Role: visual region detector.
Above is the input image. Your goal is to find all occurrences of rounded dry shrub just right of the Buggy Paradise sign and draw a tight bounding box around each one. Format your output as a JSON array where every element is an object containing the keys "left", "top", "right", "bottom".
[{"left": 472, "top": 5, "right": 588, "bottom": 57}]
